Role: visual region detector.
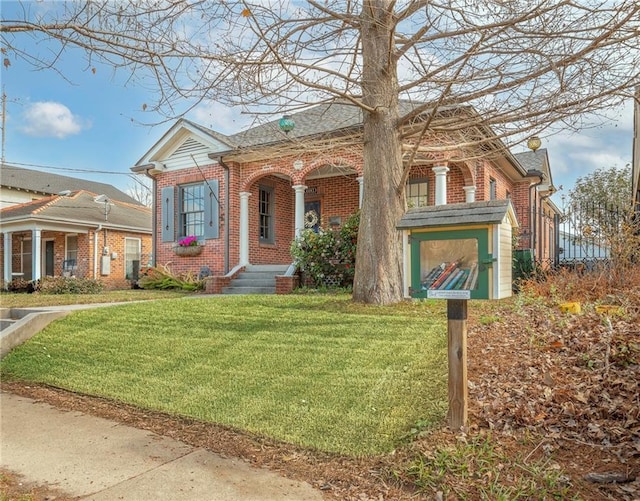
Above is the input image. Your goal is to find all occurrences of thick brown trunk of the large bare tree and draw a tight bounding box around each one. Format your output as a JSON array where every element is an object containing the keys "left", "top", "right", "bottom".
[{"left": 353, "top": 0, "right": 405, "bottom": 304}]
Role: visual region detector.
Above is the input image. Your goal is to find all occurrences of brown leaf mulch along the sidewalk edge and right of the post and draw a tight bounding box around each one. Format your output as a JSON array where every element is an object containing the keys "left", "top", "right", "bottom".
[{"left": 1, "top": 288, "right": 640, "bottom": 501}]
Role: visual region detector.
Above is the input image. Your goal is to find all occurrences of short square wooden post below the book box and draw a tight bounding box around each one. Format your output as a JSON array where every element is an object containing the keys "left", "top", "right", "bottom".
[{"left": 447, "top": 299, "right": 468, "bottom": 431}]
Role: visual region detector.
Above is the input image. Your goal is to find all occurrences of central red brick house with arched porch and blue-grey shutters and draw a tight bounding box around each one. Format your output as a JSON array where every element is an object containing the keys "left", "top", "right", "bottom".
[{"left": 131, "top": 102, "right": 553, "bottom": 292}]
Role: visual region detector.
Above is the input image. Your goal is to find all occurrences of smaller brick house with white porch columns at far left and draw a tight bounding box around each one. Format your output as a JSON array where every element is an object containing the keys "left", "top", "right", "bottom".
[{"left": 0, "top": 166, "right": 152, "bottom": 288}]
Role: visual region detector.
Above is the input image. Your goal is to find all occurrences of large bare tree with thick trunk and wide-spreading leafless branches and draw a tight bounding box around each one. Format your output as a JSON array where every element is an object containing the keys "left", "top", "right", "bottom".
[{"left": 0, "top": 0, "right": 640, "bottom": 304}]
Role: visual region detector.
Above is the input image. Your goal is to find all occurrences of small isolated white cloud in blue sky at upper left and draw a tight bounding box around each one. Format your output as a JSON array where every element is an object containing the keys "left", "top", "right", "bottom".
[{"left": 22, "top": 101, "right": 91, "bottom": 139}]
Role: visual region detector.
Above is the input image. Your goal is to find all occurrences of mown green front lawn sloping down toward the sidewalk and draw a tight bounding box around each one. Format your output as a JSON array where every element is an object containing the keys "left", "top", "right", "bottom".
[{"left": 0, "top": 295, "right": 447, "bottom": 455}]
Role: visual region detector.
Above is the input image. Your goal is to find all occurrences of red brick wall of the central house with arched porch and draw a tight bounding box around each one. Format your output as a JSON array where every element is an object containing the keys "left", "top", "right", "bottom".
[{"left": 151, "top": 143, "right": 544, "bottom": 275}]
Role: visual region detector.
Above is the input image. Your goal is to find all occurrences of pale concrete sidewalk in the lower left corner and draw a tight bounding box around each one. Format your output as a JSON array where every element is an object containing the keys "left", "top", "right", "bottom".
[{"left": 0, "top": 392, "right": 323, "bottom": 501}]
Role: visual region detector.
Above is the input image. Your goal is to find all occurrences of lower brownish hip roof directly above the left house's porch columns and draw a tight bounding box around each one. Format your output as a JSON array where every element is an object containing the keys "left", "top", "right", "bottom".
[{"left": 0, "top": 191, "right": 151, "bottom": 233}]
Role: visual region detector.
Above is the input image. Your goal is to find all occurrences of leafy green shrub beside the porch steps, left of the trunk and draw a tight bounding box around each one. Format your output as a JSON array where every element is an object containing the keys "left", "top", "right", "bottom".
[{"left": 291, "top": 212, "right": 360, "bottom": 287}]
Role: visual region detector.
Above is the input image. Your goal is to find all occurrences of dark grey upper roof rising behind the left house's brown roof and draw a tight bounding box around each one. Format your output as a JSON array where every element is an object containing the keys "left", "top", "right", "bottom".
[{"left": 0, "top": 164, "right": 140, "bottom": 205}]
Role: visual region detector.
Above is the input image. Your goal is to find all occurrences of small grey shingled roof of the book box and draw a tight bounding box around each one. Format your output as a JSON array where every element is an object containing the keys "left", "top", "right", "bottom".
[{"left": 396, "top": 200, "right": 518, "bottom": 230}]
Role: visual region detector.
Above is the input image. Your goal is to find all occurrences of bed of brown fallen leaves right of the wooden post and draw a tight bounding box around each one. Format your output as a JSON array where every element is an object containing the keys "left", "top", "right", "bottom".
[{"left": 468, "top": 287, "right": 640, "bottom": 501}]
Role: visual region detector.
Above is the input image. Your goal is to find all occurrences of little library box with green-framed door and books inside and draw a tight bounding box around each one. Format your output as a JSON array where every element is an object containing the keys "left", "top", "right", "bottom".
[{"left": 397, "top": 200, "right": 518, "bottom": 299}]
